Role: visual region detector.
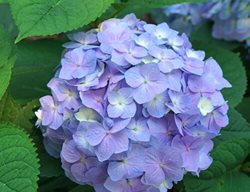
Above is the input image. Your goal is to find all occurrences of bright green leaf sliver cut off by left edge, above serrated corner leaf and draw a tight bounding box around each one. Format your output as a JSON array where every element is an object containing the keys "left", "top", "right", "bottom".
[{"left": 0, "top": 26, "right": 15, "bottom": 100}]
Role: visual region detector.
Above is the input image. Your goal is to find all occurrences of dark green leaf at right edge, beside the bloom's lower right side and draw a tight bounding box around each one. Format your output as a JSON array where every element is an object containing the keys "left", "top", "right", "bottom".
[{"left": 215, "top": 109, "right": 250, "bottom": 145}]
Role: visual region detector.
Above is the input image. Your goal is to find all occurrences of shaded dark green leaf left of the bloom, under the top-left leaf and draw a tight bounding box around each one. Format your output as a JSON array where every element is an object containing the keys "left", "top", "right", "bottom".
[{"left": 10, "top": 40, "right": 63, "bottom": 103}]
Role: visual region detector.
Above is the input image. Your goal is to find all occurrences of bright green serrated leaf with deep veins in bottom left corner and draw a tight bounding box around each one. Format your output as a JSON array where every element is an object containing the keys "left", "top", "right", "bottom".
[{"left": 0, "top": 124, "right": 39, "bottom": 192}]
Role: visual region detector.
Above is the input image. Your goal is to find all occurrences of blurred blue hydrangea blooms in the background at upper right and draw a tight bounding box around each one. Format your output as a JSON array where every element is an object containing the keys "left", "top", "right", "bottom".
[{"left": 161, "top": 0, "right": 250, "bottom": 41}]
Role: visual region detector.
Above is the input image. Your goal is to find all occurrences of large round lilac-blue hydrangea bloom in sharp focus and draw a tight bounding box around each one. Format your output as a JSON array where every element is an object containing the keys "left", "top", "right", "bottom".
[{"left": 36, "top": 14, "right": 231, "bottom": 192}]
